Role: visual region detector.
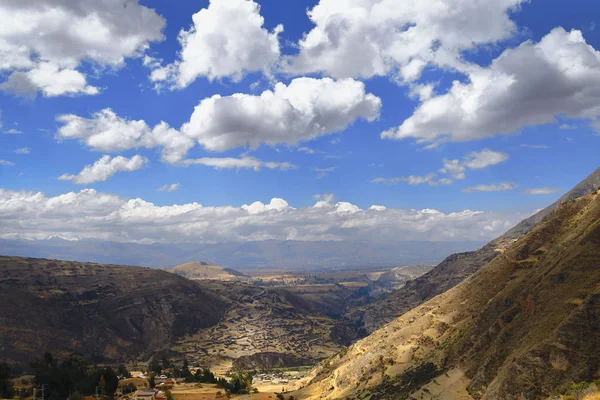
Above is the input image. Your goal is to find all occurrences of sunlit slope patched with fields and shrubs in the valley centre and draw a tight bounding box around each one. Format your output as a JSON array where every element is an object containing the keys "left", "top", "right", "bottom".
[{"left": 172, "top": 281, "right": 358, "bottom": 371}]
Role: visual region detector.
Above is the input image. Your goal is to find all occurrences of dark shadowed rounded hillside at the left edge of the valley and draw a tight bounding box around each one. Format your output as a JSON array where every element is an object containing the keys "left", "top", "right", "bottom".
[{"left": 0, "top": 257, "right": 228, "bottom": 364}]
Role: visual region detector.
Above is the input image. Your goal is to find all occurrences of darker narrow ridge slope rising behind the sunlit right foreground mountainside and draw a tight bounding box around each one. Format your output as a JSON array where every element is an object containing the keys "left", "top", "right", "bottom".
[{"left": 346, "top": 169, "right": 600, "bottom": 332}]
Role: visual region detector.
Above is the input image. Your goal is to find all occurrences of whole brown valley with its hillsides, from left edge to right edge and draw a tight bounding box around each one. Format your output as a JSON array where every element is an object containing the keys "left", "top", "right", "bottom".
[{"left": 0, "top": 170, "right": 600, "bottom": 400}]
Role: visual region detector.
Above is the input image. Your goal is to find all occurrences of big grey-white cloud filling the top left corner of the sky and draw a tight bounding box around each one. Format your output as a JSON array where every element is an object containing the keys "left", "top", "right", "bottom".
[{"left": 0, "top": 0, "right": 165, "bottom": 97}]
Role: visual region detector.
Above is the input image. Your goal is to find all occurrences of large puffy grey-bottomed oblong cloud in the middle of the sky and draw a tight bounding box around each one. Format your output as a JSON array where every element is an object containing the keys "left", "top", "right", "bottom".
[{"left": 181, "top": 78, "right": 381, "bottom": 151}]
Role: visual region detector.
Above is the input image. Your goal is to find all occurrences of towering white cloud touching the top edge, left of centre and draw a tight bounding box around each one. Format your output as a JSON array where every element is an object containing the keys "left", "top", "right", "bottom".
[{"left": 146, "top": 0, "right": 283, "bottom": 88}]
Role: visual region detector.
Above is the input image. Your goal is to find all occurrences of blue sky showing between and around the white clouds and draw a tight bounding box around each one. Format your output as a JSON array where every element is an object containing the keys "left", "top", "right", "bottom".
[{"left": 0, "top": 0, "right": 600, "bottom": 241}]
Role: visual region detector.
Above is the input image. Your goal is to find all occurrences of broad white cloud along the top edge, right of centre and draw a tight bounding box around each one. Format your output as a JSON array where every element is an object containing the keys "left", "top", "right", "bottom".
[{"left": 283, "top": 0, "right": 525, "bottom": 82}]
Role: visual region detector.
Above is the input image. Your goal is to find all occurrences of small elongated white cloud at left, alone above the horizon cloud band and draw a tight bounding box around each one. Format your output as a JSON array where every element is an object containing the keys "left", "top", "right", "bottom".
[{"left": 58, "top": 155, "right": 148, "bottom": 185}]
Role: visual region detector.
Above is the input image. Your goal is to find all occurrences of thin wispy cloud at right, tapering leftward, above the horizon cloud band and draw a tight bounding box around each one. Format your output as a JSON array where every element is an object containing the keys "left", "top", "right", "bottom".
[{"left": 371, "top": 149, "right": 509, "bottom": 186}]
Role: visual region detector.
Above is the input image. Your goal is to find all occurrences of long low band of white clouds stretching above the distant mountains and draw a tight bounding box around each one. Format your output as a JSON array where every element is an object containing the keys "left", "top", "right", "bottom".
[{"left": 0, "top": 189, "right": 519, "bottom": 243}]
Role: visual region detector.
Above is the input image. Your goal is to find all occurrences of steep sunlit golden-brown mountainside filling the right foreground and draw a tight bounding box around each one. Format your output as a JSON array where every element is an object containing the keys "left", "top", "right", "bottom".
[{"left": 294, "top": 191, "right": 600, "bottom": 400}]
